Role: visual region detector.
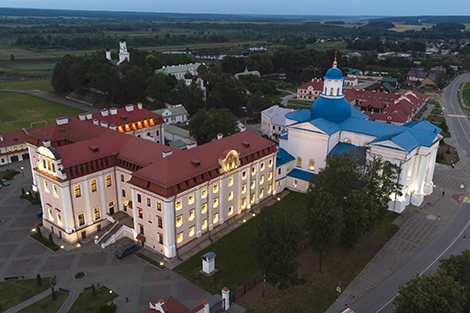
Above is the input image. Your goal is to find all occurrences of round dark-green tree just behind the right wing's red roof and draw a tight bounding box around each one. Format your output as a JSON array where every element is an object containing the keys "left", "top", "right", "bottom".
[{"left": 188, "top": 108, "right": 239, "bottom": 145}]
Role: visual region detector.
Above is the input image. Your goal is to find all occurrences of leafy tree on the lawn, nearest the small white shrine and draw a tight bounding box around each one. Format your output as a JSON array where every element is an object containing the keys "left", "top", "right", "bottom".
[{"left": 251, "top": 209, "right": 305, "bottom": 297}]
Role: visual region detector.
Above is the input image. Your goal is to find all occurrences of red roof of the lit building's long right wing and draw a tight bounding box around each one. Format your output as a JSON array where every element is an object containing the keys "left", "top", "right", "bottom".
[{"left": 131, "top": 131, "right": 277, "bottom": 197}]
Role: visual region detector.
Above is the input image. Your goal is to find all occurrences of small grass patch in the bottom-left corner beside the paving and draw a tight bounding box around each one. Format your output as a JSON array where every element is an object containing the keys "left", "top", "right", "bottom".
[{"left": 0, "top": 277, "right": 51, "bottom": 312}]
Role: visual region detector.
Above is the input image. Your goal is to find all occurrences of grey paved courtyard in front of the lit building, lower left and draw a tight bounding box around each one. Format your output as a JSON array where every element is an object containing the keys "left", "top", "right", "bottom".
[{"left": 0, "top": 162, "right": 244, "bottom": 313}]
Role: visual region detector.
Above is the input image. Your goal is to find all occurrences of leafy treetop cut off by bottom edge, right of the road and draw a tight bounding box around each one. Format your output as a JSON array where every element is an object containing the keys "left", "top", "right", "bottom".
[{"left": 393, "top": 264, "right": 468, "bottom": 313}]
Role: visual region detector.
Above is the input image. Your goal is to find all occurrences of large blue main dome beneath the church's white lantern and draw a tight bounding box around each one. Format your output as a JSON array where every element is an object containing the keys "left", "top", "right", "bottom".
[{"left": 310, "top": 94, "right": 351, "bottom": 123}]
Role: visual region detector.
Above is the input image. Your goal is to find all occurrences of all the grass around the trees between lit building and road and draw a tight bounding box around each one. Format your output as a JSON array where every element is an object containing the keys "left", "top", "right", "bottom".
[{"left": 174, "top": 193, "right": 398, "bottom": 313}]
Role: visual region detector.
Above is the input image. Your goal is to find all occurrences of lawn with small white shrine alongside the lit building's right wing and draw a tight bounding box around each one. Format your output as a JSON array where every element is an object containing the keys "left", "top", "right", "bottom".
[{"left": 174, "top": 193, "right": 305, "bottom": 294}]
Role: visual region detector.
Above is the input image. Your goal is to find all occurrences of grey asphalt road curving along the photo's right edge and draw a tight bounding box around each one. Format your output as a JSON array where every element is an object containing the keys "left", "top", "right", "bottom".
[{"left": 350, "top": 73, "right": 470, "bottom": 313}]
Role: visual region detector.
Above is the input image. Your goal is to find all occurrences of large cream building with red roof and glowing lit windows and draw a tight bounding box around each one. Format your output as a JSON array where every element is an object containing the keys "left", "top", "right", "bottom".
[{"left": 28, "top": 119, "right": 276, "bottom": 258}]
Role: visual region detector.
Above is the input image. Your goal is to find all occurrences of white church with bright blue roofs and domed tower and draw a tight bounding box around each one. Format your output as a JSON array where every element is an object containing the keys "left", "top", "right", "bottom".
[{"left": 275, "top": 60, "right": 442, "bottom": 212}]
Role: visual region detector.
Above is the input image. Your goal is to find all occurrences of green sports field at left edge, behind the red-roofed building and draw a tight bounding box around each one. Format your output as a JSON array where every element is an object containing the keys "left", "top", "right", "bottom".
[{"left": 0, "top": 92, "right": 85, "bottom": 133}]
